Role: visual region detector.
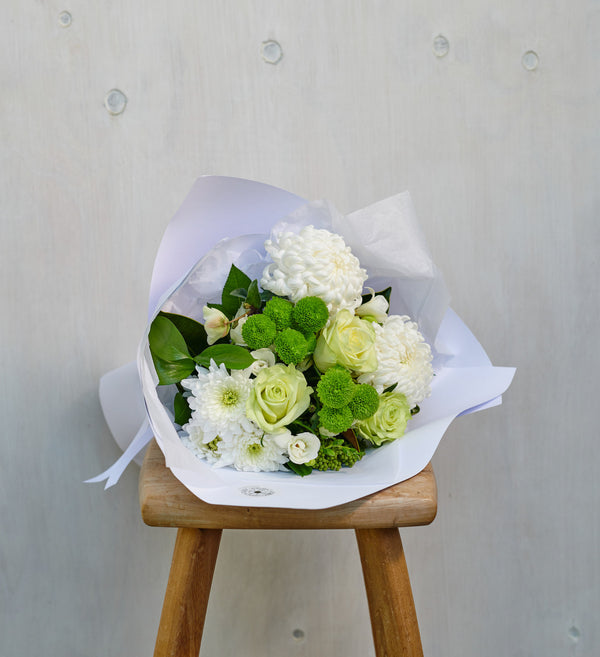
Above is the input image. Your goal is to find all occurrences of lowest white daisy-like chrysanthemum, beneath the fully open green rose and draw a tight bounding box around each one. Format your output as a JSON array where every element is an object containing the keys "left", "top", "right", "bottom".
[{"left": 216, "top": 431, "right": 288, "bottom": 472}]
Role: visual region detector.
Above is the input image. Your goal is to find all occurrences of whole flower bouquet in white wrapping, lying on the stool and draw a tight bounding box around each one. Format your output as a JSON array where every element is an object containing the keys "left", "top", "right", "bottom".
[{"left": 91, "top": 177, "right": 514, "bottom": 508}]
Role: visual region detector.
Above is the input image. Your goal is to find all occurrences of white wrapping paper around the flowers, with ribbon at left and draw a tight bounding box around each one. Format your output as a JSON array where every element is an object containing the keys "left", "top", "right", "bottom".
[{"left": 93, "top": 177, "right": 514, "bottom": 509}]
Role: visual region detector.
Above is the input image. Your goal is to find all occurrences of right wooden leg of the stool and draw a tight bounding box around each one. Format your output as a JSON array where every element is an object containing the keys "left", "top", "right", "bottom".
[{"left": 355, "top": 528, "right": 423, "bottom": 657}]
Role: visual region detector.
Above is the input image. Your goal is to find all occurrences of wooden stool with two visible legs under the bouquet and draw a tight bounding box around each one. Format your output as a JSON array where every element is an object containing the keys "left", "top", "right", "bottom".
[{"left": 139, "top": 441, "right": 437, "bottom": 657}]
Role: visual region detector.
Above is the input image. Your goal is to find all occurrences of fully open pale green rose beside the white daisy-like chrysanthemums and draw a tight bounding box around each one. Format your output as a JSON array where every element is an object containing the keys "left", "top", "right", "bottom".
[{"left": 246, "top": 363, "right": 313, "bottom": 433}]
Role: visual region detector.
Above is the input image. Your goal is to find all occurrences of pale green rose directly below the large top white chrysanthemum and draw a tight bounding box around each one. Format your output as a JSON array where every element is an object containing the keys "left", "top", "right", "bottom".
[{"left": 313, "top": 308, "right": 377, "bottom": 374}]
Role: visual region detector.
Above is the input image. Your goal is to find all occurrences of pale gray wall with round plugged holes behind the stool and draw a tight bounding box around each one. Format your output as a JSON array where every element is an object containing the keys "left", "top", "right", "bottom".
[{"left": 0, "top": 0, "right": 600, "bottom": 657}]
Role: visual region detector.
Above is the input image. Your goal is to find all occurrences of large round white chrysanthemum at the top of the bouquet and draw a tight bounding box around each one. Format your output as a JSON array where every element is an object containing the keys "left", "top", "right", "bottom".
[{"left": 260, "top": 226, "right": 367, "bottom": 316}]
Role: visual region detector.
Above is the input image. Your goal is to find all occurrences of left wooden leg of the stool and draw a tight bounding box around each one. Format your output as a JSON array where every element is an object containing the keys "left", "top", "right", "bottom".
[{"left": 154, "top": 529, "right": 221, "bottom": 657}]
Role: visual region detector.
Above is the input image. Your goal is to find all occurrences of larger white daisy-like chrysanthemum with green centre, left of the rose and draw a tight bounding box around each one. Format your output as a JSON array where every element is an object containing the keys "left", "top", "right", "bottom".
[{"left": 181, "top": 360, "right": 256, "bottom": 443}]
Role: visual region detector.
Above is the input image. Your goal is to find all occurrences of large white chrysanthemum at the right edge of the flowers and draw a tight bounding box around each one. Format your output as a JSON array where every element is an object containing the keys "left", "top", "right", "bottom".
[{"left": 358, "top": 315, "right": 433, "bottom": 408}]
